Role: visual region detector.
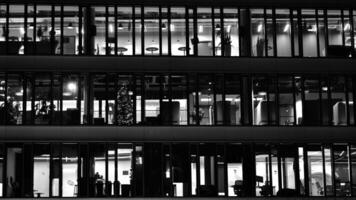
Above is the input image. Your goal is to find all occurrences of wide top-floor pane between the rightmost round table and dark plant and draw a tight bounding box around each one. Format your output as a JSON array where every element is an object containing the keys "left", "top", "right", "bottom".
[{"left": 197, "top": 8, "right": 214, "bottom": 56}]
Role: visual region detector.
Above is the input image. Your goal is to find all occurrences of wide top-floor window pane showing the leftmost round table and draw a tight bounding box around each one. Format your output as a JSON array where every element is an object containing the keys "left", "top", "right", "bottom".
[{"left": 117, "top": 6, "right": 133, "bottom": 55}]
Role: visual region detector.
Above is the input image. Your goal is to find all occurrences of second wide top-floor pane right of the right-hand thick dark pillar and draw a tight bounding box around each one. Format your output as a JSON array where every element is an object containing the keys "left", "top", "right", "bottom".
[{"left": 276, "top": 9, "right": 292, "bottom": 57}]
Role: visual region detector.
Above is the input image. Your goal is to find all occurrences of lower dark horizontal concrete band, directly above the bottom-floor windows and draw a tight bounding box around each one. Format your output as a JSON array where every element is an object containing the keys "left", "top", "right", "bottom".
[{"left": 0, "top": 126, "right": 356, "bottom": 143}]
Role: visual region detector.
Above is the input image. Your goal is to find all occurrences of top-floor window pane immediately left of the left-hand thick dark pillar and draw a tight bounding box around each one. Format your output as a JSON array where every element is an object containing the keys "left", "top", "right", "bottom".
[{"left": 63, "top": 6, "right": 81, "bottom": 55}]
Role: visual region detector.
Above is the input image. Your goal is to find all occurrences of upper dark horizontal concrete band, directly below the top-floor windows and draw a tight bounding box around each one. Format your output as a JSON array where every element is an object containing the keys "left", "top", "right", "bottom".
[{"left": 0, "top": 56, "right": 356, "bottom": 74}]
